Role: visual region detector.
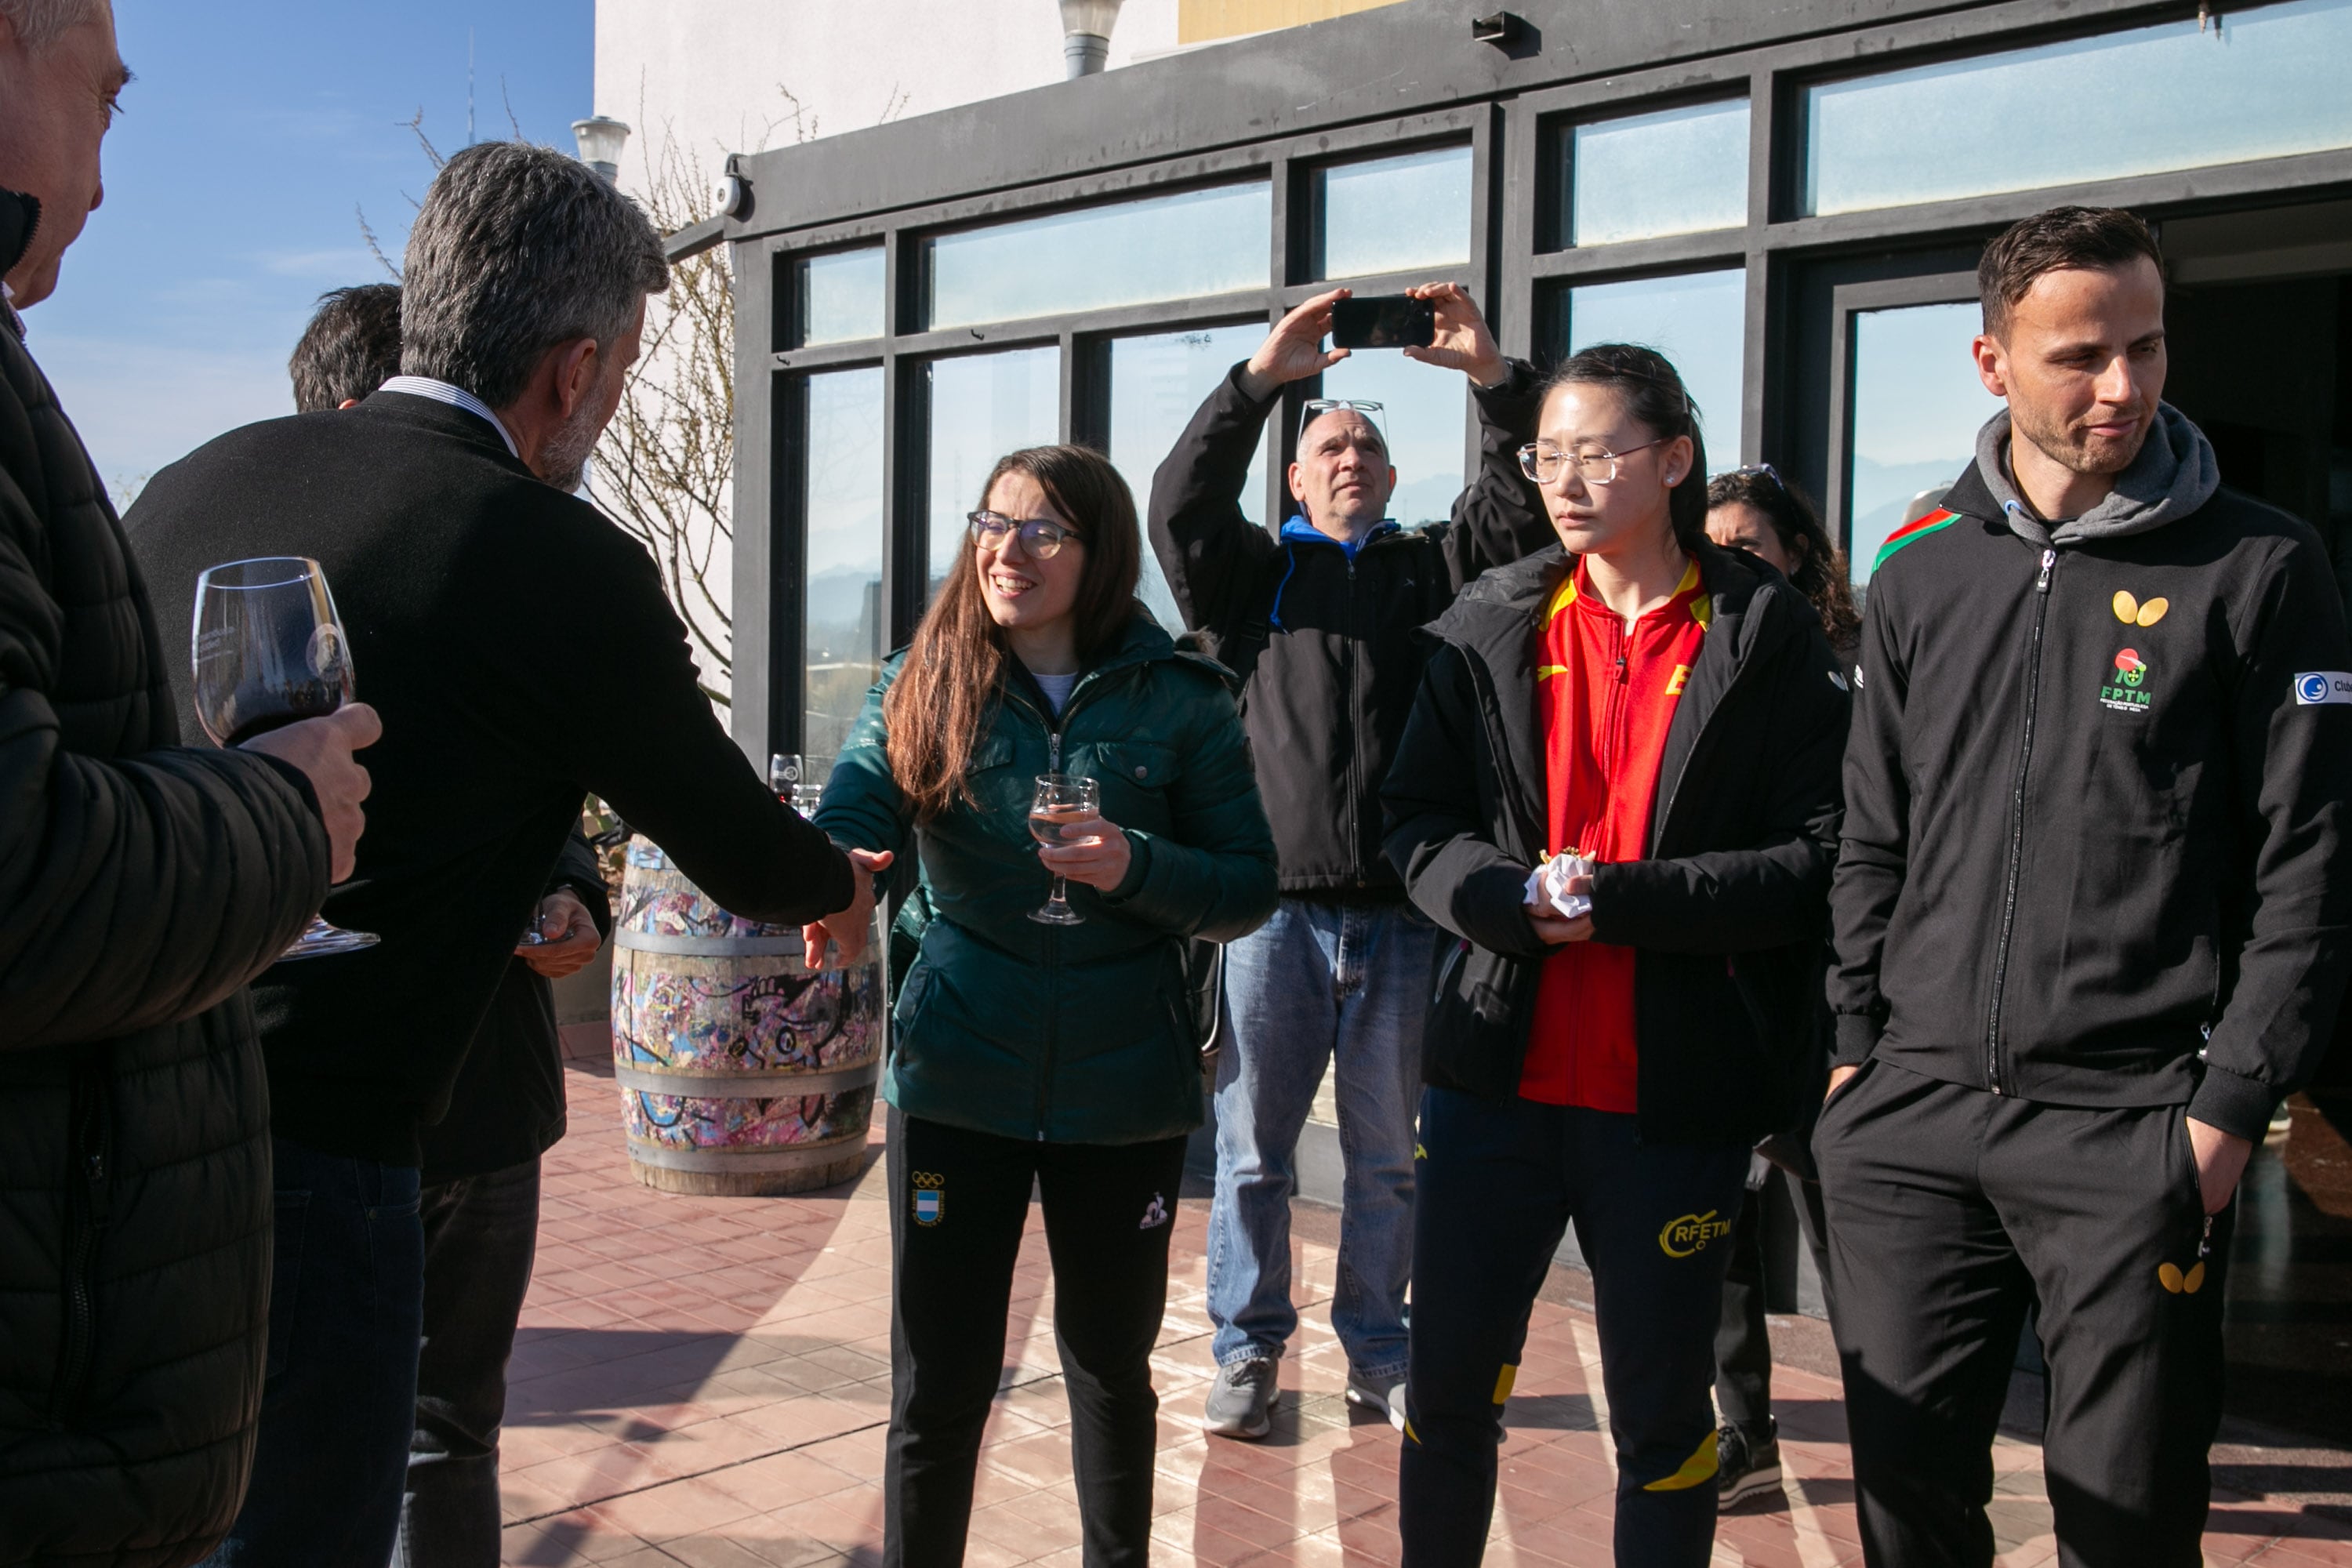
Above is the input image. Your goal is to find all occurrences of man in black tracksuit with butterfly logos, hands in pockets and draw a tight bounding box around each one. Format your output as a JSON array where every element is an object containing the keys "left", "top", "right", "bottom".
[{"left": 1816, "top": 209, "right": 2352, "bottom": 1568}]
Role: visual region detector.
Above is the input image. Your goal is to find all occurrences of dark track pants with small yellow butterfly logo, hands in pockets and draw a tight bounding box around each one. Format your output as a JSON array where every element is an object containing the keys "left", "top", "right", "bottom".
[{"left": 1813, "top": 1062, "right": 2237, "bottom": 1568}]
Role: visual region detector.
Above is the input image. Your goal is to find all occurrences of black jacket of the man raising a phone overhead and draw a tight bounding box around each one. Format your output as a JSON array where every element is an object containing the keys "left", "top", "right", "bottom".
[{"left": 1150, "top": 360, "right": 1552, "bottom": 902}]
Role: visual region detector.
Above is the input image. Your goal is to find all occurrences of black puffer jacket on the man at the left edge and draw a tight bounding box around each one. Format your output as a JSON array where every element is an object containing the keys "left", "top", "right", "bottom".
[{"left": 0, "top": 191, "right": 327, "bottom": 1563}]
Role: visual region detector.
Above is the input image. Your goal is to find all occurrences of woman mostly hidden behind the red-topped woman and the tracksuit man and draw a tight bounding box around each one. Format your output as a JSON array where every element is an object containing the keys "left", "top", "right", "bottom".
[{"left": 1708, "top": 463, "right": 1863, "bottom": 1509}]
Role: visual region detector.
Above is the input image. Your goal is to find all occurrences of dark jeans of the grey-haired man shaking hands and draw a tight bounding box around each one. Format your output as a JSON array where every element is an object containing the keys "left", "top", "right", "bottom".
[{"left": 205, "top": 1138, "right": 426, "bottom": 1568}]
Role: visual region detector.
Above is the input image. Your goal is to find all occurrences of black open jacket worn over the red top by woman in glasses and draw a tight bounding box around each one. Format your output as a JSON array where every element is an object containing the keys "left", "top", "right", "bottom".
[{"left": 1381, "top": 543, "right": 1849, "bottom": 1142}]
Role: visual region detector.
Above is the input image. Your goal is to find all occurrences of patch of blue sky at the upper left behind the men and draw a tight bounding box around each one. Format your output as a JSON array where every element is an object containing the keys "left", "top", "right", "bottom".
[{"left": 26, "top": 0, "right": 595, "bottom": 494}]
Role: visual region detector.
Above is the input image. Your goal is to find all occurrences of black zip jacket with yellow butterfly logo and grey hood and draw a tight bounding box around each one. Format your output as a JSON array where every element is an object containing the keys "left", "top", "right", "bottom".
[{"left": 1830, "top": 423, "right": 2352, "bottom": 1142}]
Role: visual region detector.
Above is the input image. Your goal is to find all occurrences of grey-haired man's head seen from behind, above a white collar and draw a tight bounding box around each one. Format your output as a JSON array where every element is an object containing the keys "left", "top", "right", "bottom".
[{"left": 400, "top": 141, "right": 670, "bottom": 489}]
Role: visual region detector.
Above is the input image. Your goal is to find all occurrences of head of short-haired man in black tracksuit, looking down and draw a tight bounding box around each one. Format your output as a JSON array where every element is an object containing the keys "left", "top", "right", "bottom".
[{"left": 1976, "top": 207, "right": 2164, "bottom": 494}]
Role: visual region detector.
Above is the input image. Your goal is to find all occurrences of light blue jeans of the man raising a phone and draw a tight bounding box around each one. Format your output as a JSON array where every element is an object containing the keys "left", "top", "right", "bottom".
[{"left": 1209, "top": 898, "right": 1437, "bottom": 1392}]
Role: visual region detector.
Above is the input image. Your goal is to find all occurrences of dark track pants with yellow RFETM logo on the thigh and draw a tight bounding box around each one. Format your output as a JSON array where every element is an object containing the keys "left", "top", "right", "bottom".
[{"left": 1397, "top": 1088, "right": 1748, "bottom": 1568}]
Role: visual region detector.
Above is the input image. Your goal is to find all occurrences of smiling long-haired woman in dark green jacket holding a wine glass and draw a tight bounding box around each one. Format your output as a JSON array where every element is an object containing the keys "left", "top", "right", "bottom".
[{"left": 816, "top": 447, "right": 1275, "bottom": 1568}]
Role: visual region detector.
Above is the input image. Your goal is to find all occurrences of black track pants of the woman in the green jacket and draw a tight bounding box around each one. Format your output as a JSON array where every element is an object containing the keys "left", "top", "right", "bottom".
[{"left": 882, "top": 1109, "right": 1185, "bottom": 1568}]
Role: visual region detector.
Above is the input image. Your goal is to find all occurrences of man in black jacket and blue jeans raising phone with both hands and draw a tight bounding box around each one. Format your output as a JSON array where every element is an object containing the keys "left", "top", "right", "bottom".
[{"left": 1150, "top": 285, "right": 1552, "bottom": 1439}]
